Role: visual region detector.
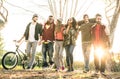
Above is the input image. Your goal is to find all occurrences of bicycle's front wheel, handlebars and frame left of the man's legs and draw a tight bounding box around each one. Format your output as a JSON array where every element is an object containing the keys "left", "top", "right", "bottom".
[{"left": 2, "top": 40, "right": 28, "bottom": 70}]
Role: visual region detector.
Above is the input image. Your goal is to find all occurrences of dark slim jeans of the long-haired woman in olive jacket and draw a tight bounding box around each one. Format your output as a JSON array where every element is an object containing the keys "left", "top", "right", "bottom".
[{"left": 65, "top": 44, "right": 75, "bottom": 66}]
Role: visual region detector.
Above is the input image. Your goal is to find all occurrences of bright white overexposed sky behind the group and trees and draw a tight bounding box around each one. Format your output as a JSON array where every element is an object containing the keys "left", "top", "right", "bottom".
[{"left": 1, "top": 0, "right": 120, "bottom": 61}]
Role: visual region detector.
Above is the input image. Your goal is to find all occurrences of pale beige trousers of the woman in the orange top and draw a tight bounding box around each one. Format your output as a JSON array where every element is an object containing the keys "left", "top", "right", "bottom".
[{"left": 54, "top": 41, "right": 63, "bottom": 68}]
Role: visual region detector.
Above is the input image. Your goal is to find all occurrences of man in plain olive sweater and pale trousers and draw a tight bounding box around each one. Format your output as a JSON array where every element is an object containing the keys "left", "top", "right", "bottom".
[{"left": 79, "top": 14, "right": 93, "bottom": 73}]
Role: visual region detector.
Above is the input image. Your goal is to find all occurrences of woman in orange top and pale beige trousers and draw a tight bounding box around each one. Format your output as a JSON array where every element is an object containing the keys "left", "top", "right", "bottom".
[{"left": 54, "top": 18, "right": 64, "bottom": 71}]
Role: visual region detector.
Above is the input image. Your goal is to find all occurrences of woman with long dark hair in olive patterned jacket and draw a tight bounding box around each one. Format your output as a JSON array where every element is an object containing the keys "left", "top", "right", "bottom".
[{"left": 64, "top": 17, "right": 77, "bottom": 72}]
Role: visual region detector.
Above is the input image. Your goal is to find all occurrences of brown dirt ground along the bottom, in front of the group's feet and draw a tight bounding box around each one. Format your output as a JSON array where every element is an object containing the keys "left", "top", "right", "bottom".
[{"left": 0, "top": 69, "right": 120, "bottom": 79}]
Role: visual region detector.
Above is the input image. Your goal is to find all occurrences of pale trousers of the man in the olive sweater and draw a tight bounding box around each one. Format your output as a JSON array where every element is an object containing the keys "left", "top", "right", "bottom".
[{"left": 82, "top": 42, "right": 91, "bottom": 71}]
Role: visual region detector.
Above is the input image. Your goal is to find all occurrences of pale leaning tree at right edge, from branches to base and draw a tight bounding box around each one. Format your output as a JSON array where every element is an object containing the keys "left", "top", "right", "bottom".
[{"left": 105, "top": 0, "right": 120, "bottom": 71}]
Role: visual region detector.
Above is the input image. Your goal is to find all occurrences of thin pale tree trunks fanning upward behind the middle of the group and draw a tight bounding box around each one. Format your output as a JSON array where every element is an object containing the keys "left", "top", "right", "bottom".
[{"left": 48, "top": 0, "right": 95, "bottom": 22}]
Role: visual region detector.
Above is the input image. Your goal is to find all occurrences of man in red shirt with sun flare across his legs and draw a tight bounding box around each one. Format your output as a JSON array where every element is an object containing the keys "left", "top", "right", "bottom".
[{"left": 92, "top": 14, "right": 109, "bottom": 74}]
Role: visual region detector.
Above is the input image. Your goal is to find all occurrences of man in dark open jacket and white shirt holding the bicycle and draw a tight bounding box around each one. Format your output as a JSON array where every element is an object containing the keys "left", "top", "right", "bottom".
[{"left": 18, "top": 14, "right": 42, "bottom": 69}]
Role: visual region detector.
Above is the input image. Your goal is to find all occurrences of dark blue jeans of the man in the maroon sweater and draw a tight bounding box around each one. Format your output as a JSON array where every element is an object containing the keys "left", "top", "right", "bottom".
[{"left": 42, "top": 42, "right": 53, "bottom": 63}]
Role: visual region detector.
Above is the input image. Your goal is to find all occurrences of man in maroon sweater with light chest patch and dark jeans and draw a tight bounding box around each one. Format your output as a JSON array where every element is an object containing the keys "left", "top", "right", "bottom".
[{"left": 42, "top": 16, "right": 55, "bottom": 67}]
